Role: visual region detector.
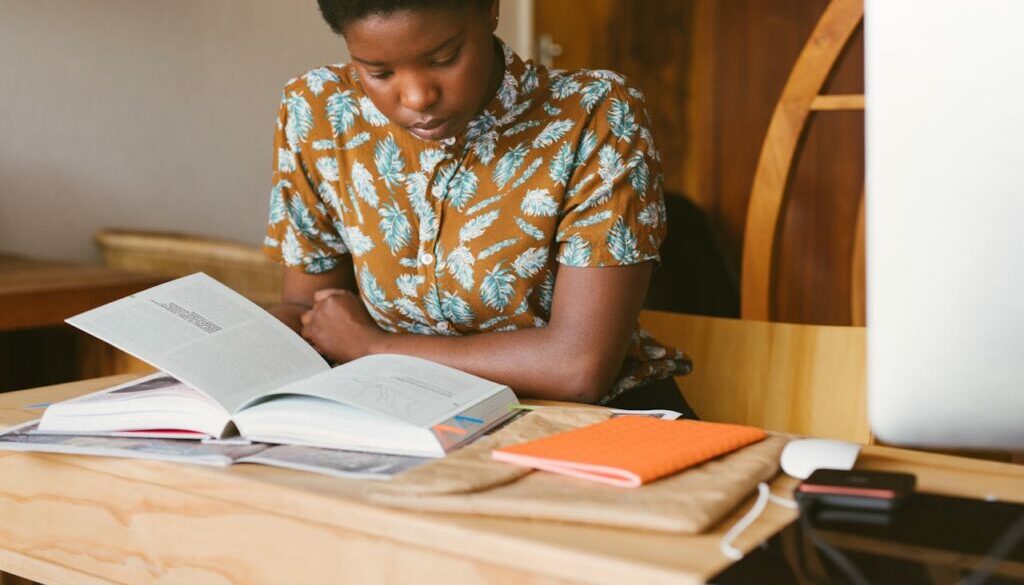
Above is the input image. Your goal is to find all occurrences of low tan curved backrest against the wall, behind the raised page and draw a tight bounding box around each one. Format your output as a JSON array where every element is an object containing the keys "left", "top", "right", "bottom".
[{"left": 95, "top": 228, "right": 282, "bottom": 306}]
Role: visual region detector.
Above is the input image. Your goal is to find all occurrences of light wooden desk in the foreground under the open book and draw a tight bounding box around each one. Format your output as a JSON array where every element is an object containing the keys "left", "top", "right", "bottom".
[{"left": 0, "top": 376, "right": 1024, "bottom": 585}]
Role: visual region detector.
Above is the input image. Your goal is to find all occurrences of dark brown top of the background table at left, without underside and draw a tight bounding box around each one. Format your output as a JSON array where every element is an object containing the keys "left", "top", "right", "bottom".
[{"left": 0, "top": 254, "right": 163, "bottom": 331}]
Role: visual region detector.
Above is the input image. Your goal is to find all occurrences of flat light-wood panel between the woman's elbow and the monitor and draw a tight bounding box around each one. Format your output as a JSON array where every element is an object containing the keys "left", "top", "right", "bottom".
[{"left": 640, "top": 310, "right": 870, "bottom": 443}]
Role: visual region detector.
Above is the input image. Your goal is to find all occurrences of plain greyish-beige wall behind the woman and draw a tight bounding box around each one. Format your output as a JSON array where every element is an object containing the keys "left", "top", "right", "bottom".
[{"left": 0, "top": 0, "right": 531, "bottom": 260}]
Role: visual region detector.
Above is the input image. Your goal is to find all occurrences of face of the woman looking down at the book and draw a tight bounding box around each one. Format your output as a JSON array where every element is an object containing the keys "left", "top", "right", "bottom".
[{"left": 344, "top": 0, "right": 502, "bottom": 140}]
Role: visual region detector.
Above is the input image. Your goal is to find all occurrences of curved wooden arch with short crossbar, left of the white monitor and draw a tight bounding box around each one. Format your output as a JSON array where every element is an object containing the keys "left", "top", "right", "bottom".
[{"left": 740, "top": 0, "right": 864, "bottom": 325}]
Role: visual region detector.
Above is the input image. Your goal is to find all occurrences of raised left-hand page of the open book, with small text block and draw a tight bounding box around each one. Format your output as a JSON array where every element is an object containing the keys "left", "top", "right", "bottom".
[{"left": 68, "top": 273, "right": 329, "bottom": 412}]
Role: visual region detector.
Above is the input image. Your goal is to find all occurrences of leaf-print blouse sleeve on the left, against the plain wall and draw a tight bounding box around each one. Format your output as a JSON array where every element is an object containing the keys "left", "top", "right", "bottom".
[{"left": 263, "top": 84, "right": 348, "bottom": 274}]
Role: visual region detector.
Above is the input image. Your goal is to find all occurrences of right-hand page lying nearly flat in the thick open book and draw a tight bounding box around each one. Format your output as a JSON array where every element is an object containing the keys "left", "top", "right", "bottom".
[{"left": 252, "top": 354, "right": 514, "bottom": 428}]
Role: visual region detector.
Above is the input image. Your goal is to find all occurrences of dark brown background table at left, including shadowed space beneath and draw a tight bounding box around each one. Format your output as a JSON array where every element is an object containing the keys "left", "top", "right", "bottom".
[{"left": 0, "top": 254, "right": 164, "bottom": 391}]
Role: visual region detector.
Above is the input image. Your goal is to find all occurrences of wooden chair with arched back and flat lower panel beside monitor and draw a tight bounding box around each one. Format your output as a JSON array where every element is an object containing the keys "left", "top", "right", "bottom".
[{"left": 640, "top": 0, "right": 871, "bottom": 443}]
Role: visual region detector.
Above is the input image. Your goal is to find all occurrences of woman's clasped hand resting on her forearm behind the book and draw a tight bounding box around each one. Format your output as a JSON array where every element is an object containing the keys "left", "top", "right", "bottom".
[{"left": 302, "top": 289, "right": 387, "bottom": 363}]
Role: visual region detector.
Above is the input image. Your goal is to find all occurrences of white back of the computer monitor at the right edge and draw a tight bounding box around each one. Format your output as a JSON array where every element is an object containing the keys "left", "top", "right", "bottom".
[{"left": 864, "top": 0, "right": 1024, "bottom": 451}]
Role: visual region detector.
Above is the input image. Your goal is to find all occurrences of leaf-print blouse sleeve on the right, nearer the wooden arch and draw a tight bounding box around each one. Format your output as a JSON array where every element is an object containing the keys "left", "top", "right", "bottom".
[{"left": 557, "top": 83, "right": 667, "bottom": 266}]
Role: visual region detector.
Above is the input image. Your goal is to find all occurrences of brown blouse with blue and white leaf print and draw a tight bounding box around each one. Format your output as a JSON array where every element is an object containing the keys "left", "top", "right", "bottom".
[{"left": 264, "top": 37, "right": 690, "bottom": 402}]
